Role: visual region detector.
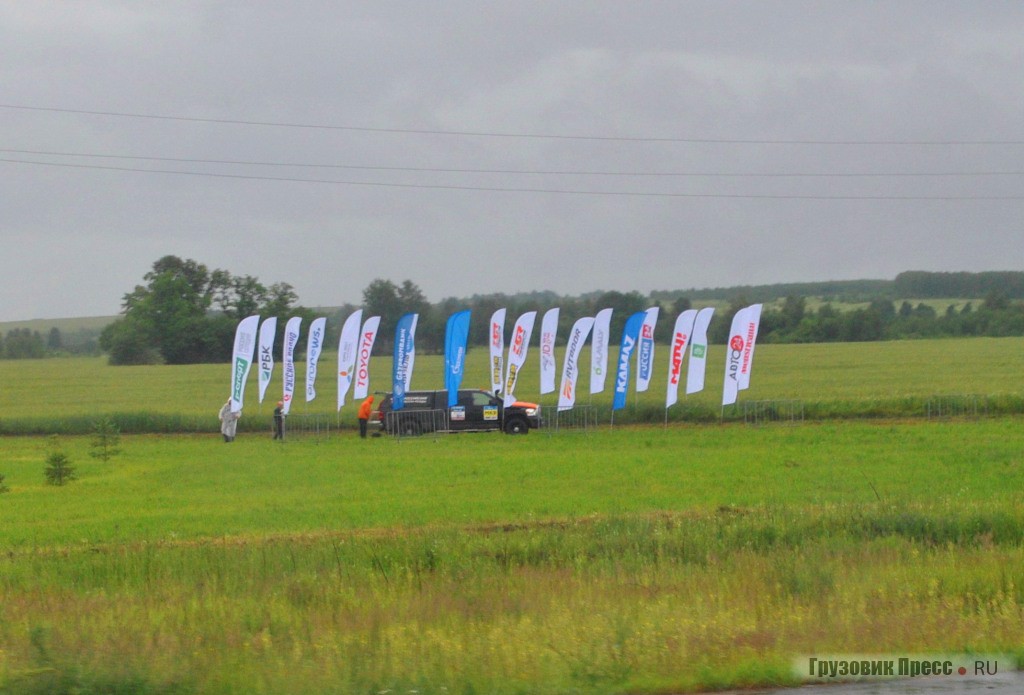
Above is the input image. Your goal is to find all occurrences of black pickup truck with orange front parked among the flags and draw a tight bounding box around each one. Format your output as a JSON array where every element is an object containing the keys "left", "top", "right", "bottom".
[{"left": 370, "top": 389, "right": 542, "bottom": 435}]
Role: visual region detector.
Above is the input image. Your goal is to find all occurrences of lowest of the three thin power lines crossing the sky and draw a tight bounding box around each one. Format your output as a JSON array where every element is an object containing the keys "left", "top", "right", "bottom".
[{"left": 0, "top": 158, "right": 1024, "bottom": 201}]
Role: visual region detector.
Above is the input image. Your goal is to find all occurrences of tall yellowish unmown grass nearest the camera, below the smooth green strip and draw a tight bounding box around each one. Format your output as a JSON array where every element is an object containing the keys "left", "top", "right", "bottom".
[{"left": 0, "top": 506, "right": 1024, "bottom": 694}]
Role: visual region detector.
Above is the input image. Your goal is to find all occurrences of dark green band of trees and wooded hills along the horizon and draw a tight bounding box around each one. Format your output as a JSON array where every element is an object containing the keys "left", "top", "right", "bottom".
[{"left": 0, "top": 256, "right": 1024, "bottom": 364}]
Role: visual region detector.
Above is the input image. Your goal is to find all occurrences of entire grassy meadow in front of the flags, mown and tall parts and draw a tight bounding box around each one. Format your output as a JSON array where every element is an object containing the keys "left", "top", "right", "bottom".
[{"left": 0, "top": 419, "right": 1024, "bottom": 693}]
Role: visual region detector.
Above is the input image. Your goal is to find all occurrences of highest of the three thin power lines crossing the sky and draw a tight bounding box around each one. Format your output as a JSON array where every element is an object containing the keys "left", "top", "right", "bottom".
[{"left": 0, "top": 103, "right": 1024, "bottom": 146}]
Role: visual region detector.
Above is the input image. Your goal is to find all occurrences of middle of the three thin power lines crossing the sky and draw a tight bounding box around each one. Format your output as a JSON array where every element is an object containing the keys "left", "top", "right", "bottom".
[{"left": 0, "top": 148, "right": 1024, "bottom": 178}]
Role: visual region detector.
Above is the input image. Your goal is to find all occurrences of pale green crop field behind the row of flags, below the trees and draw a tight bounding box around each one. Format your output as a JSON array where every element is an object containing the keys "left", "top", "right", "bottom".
[{"left": 0, "top": 338, "right": 1024, "bottom": 434}]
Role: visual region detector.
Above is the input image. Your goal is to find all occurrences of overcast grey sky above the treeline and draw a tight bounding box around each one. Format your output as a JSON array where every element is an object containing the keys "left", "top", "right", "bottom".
[{"left": 0, "top": 0, "right": 1024, "bottom": 320}]
